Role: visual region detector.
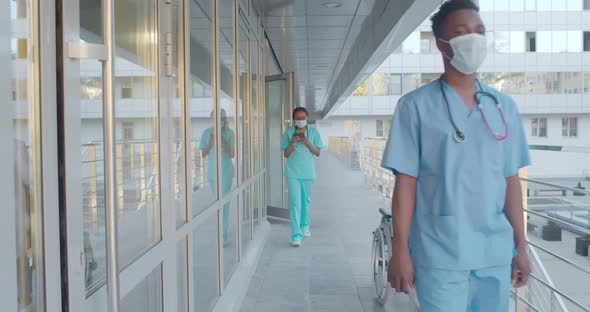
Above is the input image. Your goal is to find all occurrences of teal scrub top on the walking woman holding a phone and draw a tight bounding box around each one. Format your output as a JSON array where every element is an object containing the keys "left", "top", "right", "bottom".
[{"left": 281, "top": 126, "right": 325, "bottom": 180}]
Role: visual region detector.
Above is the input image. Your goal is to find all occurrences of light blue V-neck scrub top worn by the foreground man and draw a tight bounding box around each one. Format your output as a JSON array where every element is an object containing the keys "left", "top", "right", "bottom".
[{"left": 382, "top": 80, "right": 530, "bottom": 270}]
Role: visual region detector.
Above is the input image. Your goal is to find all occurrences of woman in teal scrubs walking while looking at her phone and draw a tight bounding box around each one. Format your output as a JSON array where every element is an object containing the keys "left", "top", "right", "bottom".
[{"left": 281, "top": 107, "right": 324, "bottom": 247}]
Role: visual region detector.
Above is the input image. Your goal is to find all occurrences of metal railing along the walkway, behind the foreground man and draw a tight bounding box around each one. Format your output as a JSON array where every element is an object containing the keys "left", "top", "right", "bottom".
[{"left": 359, "top": 138, "right": 590, "bottom": 312}]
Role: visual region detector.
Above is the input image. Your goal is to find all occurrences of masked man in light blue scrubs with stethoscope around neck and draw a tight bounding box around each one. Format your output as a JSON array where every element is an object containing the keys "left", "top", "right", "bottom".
[{"left": 382, "top": 0, "right": 529, "bottom": 312}]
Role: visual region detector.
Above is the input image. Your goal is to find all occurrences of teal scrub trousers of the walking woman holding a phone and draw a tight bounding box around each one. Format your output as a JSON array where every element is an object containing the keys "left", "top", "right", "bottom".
[{"left": 286, "top": 178, "right": 313, "bottom": 239}]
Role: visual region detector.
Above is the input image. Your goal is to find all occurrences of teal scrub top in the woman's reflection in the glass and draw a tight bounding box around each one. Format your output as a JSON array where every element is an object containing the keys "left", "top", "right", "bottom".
[{"left": 199, "top": 127, "right": 235, "bottom": 183}]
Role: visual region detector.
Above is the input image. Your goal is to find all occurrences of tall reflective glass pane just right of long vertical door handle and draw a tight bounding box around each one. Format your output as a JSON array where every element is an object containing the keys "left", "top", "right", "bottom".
[{"left": 114, "top": 0, "right": 160, "bottom": 266}]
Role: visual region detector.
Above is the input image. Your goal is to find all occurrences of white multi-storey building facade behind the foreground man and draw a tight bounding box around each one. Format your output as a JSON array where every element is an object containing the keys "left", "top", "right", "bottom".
[{"left": 319, "top": 0, "right": 590, "bottom": 178}]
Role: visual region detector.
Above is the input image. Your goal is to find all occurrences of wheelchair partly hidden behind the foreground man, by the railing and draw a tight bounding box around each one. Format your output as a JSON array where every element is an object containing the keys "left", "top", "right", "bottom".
[{"left": 371, "top": 208, "right": 419, "bottom": 311}]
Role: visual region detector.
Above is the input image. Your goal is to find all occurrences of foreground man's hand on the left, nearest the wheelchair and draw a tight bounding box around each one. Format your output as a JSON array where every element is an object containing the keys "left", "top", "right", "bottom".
[{"left": 387, "top": 240, "right": 415, "bottom": 294}]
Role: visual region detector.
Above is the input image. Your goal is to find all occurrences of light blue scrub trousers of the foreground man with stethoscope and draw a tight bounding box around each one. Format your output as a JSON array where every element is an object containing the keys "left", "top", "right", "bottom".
[{"left": 415, "top": 265, "right": 511, "bottom": 312}]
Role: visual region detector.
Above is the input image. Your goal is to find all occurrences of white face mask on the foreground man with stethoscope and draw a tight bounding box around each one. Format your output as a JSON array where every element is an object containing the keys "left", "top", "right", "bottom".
[{"left": 439, "top": 33, "right": 488, "bottom": 75}]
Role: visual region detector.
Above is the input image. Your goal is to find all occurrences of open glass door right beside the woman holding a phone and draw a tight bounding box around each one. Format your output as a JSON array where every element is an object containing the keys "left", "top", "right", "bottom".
[{"left": 266, "top": 74, "right": 294, "bottom": 219}]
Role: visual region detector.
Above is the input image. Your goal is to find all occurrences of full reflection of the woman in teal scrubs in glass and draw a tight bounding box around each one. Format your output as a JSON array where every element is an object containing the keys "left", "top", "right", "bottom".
[{"left": 199, "top": 109, "right": 235, "bottom": 242}]
